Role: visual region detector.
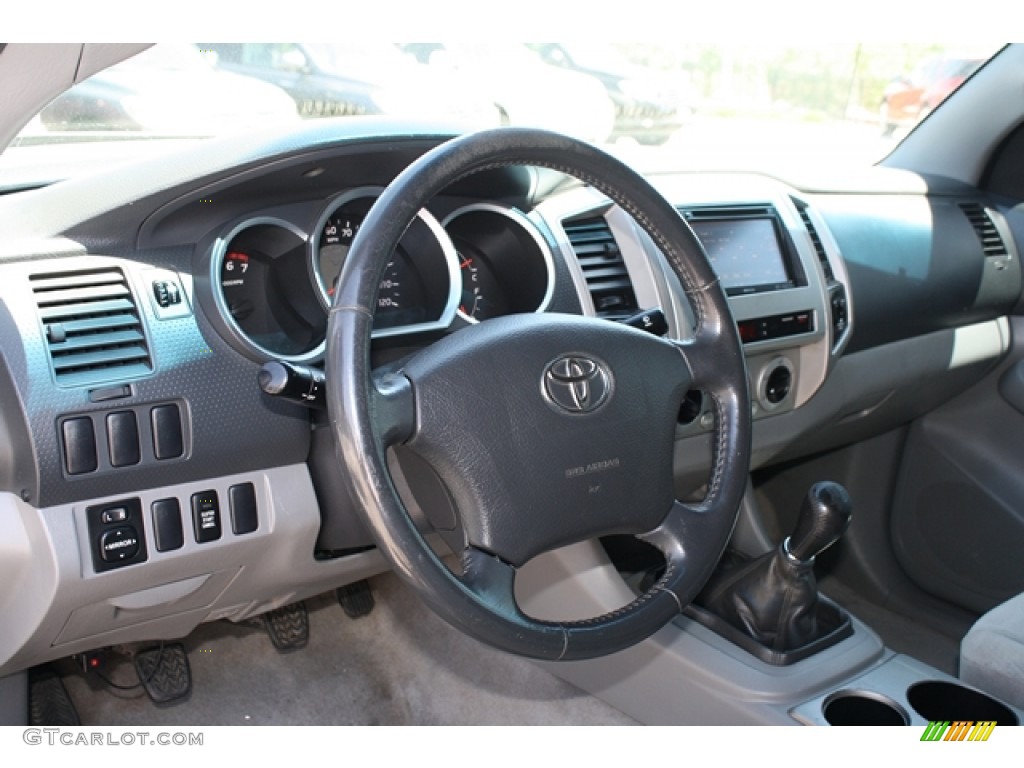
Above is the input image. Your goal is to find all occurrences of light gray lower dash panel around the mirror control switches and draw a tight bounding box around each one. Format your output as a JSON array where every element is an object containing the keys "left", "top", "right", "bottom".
[{"left": 0, "top": 464, "right": 386, "bottom": 675}]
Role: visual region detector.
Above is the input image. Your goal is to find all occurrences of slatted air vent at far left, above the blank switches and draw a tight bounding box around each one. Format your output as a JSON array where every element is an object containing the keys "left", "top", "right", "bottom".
[{"left": 29, "top": 267, "right": 153, "bottom": 387}]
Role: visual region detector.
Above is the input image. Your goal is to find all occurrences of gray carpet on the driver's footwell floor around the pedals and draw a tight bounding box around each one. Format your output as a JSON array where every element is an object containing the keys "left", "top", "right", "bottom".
[{"left": 65, "top": 574, "right": 636, "bottom": 726}]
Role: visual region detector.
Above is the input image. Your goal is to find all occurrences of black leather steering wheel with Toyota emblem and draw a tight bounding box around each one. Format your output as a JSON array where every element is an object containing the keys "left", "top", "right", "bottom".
[{"left": 327, "top": 128, "right": 751, "bottom": 660}]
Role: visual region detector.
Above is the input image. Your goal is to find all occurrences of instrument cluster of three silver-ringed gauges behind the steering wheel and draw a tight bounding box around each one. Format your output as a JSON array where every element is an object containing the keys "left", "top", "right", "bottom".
[{"left": 210, "top": 186, "right": 554, "bottom": 362}]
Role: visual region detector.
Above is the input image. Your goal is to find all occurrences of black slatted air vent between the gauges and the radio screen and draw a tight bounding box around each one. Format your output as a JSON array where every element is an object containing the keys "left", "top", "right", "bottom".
[{"left": 562, "top": 216, "right": 637, "bottom": 319}]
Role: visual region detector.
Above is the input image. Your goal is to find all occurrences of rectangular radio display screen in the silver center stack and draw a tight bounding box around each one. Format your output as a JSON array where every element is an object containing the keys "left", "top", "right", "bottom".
[{"left": 689, "top": 216, "right": 794, "bottom": 296}]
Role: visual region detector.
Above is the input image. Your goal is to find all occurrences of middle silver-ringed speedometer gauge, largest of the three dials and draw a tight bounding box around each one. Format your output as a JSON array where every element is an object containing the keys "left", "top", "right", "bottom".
[{"left": 312, "top": 187, "right": 460, "bottom": 336}]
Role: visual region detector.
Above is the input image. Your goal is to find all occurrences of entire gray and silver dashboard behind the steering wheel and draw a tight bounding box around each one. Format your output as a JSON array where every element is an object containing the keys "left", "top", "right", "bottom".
[{"left": 0, "top": 121, "right": 1021, "bottom": 674}]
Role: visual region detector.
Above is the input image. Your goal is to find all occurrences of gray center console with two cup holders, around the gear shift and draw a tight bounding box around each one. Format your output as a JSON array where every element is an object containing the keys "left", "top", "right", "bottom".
[{"left": 517, "top": 483, "right": 1024, "bottom": 724}]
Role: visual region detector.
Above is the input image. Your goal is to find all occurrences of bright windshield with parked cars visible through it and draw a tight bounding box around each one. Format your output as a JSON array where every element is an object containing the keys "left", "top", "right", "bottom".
[{"left": 0, "top": 41, "right": 997, "bottom": 178}]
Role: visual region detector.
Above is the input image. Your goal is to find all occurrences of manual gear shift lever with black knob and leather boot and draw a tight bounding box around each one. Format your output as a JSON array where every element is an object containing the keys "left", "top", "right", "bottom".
[{"left": 698, "top": 482, "right": 852, "bottom": 652}]
